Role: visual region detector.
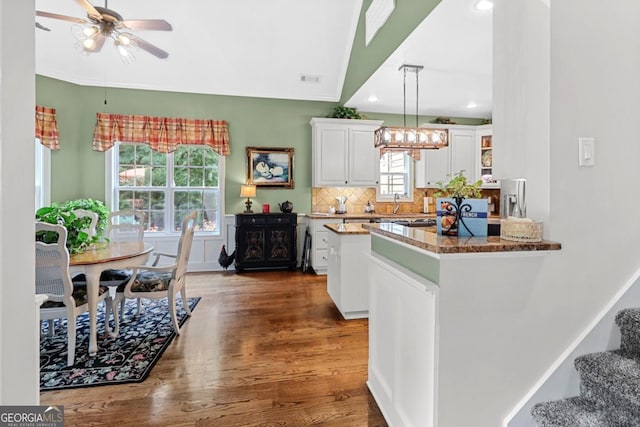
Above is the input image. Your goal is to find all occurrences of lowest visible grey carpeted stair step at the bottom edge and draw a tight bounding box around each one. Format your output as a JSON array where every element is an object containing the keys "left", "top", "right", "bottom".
[{"left": 531, "top": 396, "right": 637, "bottom": 427}]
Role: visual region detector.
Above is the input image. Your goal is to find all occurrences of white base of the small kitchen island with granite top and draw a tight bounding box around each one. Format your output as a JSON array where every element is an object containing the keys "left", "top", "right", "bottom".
[{"left": 325, "top": 227, "right": 371, "bottom": 319}]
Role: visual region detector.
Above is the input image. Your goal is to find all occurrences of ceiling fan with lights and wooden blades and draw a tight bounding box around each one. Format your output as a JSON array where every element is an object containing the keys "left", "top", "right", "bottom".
[{"left": 36, "top": 0, "right": 173, "bottom": 62}]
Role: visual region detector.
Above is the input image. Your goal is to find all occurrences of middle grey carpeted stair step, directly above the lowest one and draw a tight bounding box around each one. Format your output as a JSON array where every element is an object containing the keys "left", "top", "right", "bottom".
[{"left": 574, "top": 350, "right": 640, "bottom": 414}]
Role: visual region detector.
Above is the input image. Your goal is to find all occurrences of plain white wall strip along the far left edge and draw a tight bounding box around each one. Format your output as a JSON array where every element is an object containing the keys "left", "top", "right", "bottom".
[{"left": 0, "top": 0, "right": 40, "bottom": 405}]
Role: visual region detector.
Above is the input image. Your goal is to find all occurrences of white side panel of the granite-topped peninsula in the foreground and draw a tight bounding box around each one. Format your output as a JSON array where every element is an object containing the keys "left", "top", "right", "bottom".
[{"left": 367, "top": 255, "right": 438, "bottom": 427}]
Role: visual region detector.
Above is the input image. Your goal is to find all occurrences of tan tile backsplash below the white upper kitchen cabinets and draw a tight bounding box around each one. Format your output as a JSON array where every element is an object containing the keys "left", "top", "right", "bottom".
[{"left": 311, "top": 187, "right": 500, "bottom": 215}]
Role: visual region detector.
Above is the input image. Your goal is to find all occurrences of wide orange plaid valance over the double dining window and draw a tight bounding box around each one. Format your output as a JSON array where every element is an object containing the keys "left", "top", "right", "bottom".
[{"left": 93, "top": 113, "right": 231, "bottom": 156}]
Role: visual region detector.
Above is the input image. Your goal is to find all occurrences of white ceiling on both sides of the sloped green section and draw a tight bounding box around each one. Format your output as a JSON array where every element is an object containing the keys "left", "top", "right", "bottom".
[{"left": 35, "top": 0, "right": 491, "bottom": 117}]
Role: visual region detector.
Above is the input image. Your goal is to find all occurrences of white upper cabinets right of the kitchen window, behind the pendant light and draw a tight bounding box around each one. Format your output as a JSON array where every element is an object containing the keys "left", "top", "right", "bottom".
[{"left": 415, "top": 124, "right": 493, "bottom": 188}]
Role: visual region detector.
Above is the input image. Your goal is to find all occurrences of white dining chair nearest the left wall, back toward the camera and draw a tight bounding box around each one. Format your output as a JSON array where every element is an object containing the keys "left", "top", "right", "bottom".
[{"left": 35, "top": 221, "right": 112, "bottom": 366}]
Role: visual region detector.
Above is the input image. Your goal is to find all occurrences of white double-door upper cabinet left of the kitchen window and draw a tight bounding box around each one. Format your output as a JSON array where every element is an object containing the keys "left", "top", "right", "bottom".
[{"left": 310, "top": 118, "right": 382, "bottom": 187}]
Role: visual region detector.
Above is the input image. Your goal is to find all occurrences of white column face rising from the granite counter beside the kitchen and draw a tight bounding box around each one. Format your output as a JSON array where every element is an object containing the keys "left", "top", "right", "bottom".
[{"left": 493, "top": 0, "right": 550, "bottom": 226}]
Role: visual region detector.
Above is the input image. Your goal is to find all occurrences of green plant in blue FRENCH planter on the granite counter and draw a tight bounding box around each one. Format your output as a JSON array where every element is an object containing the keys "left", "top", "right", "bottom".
[{"left": 434, "top": 171, "right": 488, "bottom": 237}]
